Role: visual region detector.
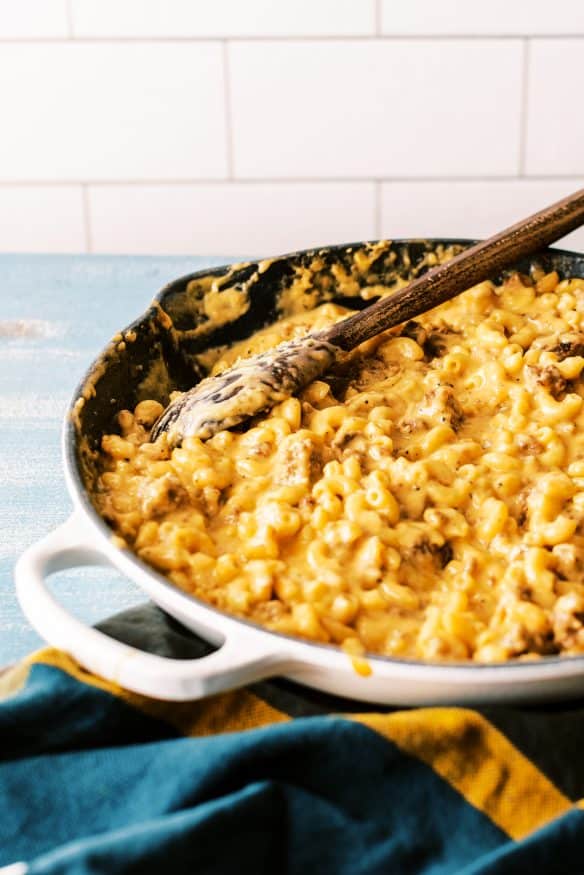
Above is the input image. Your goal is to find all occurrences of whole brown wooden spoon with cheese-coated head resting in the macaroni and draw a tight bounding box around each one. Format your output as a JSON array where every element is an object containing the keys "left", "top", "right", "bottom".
[{"left": 150, "top": 189, "right": 584, "bottom": 446}]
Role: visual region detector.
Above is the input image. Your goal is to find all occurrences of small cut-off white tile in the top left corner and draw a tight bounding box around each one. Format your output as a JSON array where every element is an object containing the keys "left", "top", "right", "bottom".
[{"left": 0, "top": 0, "right": 69, "bottom": 40}]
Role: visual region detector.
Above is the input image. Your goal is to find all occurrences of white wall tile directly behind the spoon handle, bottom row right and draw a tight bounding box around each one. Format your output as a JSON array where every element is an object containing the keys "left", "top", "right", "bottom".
[{"left": 381, "top": 179, "right": 584, "bottom": 250}]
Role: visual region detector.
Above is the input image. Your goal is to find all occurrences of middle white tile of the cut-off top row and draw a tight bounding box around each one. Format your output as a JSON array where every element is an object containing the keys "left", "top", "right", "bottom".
[{"left": 71, "top": 0, "right": 375, "bottom": 37}]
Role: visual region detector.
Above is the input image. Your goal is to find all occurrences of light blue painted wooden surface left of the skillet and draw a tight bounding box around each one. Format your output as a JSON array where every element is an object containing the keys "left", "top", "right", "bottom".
[{"left": 0, "top": 255, "right": 234, "bottom": 666}]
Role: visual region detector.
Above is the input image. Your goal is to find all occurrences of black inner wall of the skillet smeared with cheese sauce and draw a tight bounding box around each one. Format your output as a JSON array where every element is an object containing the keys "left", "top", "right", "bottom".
[{"left": 69, "top": 239, "right": 584, "bottom": 487}]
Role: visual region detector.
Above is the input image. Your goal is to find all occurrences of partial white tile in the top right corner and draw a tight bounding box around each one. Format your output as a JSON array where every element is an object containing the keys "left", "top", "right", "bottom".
[{"left": 381, "top": 0, "right": 584, "bottom": 36}]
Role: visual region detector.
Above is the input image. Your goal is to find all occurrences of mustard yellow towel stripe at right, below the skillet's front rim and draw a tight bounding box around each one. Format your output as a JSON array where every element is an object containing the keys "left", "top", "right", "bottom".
[{"left": 354, "top": 708, "right": 571, "bottom": 840}]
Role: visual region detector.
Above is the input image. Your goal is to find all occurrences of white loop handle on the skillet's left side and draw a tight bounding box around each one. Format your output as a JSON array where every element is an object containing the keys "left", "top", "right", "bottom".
[{"left": 15, "top": 514, "right": 290, "bottom": 702}]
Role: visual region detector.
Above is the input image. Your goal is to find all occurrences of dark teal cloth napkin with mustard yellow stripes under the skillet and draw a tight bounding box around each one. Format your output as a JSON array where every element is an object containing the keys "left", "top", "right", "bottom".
[{"left": 0, "top": 606, "right": 584, "bottom": 875}]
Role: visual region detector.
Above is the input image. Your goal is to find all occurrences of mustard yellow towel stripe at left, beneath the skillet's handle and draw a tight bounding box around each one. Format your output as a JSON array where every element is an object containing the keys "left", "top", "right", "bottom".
[{"left": 26, "top": 647, "right": 290, "bottom": 736}]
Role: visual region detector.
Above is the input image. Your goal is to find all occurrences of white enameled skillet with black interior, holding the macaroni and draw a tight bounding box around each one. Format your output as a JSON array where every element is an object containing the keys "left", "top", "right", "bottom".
[{"left": 15, "top": 240, "right": 584, "bottom": 705}]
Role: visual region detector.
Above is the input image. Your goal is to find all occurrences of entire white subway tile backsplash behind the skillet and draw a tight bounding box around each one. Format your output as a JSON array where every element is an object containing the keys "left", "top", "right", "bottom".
[{"left": 0, "top": 6, "right": 584, "bottom": 256}]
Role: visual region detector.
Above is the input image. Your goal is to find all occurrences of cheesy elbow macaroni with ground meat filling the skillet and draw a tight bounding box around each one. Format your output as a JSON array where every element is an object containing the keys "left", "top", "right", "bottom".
[{"left": 93, "top": 274, "right": 584, "bottom": 662}]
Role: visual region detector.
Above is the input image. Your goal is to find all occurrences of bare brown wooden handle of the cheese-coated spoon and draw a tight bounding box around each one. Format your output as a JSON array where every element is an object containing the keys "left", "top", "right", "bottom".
[{"left": 322, "top": 189, "right": 584, "bottom": 350}]
